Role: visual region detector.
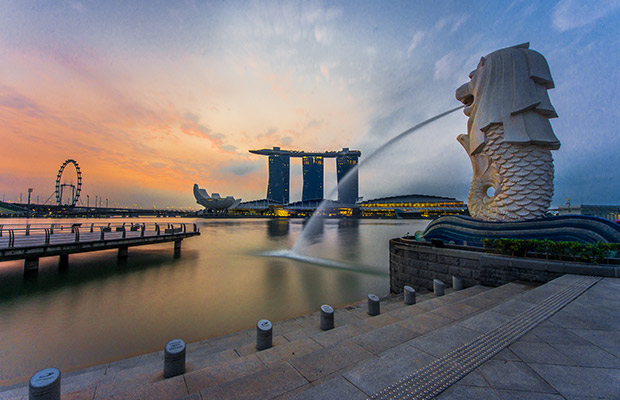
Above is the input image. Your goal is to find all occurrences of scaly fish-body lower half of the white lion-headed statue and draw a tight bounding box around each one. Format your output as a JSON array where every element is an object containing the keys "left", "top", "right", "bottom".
[{"left": 468, "top": 124, "right": 554, "bottom": 222}]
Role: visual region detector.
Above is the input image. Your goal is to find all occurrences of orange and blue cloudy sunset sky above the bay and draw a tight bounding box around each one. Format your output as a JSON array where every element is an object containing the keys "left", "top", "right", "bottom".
[{"left": 0, "top": 0, "right": 620, "bottom": 208}]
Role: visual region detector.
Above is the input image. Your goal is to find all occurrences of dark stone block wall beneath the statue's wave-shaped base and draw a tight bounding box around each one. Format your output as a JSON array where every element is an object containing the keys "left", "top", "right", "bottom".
[{"left": 390, "top": 238, "right": 620, "bottom": 293}]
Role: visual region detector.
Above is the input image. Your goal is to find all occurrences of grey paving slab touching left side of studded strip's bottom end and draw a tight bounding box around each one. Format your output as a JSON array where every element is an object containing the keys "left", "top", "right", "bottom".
[{"left": 342, "top": 345, "right": 436, "bottom": 396}]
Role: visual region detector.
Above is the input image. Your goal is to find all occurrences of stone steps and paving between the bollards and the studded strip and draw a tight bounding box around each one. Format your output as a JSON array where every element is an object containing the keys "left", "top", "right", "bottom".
[{"left": 0, "top": 283, "right": 536, "bottom": 399}]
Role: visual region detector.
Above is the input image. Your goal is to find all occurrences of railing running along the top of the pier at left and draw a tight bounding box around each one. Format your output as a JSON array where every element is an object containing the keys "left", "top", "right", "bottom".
[{"left": 0, "top": 222, "right": 199, "bottom": 249}]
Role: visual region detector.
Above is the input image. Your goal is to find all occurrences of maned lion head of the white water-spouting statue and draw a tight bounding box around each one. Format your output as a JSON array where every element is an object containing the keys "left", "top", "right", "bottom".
[{"left": 456, "top": 43, "right": 560, "bottom": 155}]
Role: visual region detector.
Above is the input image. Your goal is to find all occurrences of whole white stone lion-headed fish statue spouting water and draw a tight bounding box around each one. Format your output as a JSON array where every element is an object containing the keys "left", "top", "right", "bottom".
[{"left": 456, "top": 43, "right": 560, "bottom": 221}]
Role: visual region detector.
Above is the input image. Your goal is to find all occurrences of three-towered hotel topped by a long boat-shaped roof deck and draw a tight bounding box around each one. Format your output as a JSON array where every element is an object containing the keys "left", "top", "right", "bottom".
[{"left": 250, "top": 147, "right": 362, "bottom": 204}]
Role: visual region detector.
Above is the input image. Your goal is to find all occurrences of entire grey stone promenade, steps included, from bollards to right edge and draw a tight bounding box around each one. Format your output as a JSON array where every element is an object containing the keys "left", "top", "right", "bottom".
[{"left": 0, "top": 275, "right": 620, "bottom": 399}]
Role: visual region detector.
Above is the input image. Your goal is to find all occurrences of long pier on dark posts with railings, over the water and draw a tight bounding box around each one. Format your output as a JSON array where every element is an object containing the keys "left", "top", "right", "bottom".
[{"left": 0, "top": 223, "right": 200, "bottom": 272}]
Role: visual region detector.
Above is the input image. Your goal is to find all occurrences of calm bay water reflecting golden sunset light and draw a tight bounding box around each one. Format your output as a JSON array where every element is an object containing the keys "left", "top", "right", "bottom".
[{"left": 0, "top": 218, "right": 428, "bottom": 386}]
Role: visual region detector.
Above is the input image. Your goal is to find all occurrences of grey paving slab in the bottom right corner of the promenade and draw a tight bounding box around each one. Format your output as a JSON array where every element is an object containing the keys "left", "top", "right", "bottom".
[{"left": 530, "top": 364, "right": 620, "bottom": 399}]
